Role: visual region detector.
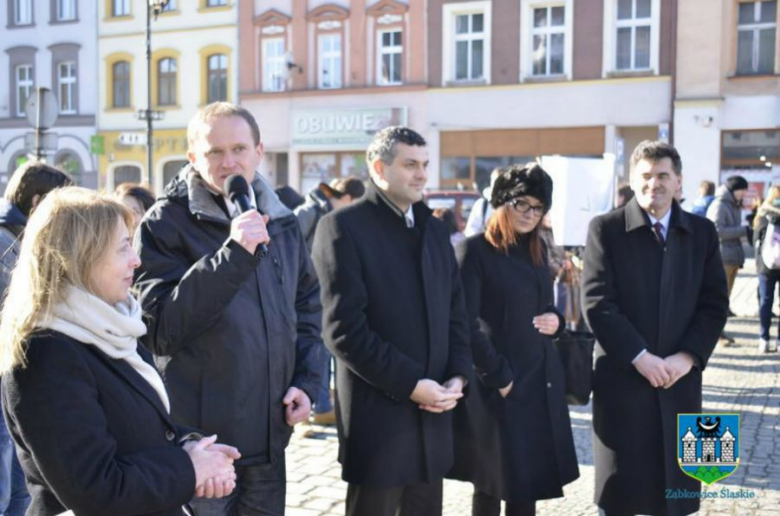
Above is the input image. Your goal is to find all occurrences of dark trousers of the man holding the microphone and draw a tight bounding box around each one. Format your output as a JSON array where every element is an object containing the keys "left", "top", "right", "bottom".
[{"left": 190, "top": 460, "right": 287, "bottom": 516}]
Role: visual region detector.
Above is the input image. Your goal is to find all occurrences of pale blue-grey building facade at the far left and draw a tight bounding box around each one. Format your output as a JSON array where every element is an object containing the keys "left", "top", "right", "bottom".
[{"left": 0, "top": 0, "right": 98, "bottom": 190}]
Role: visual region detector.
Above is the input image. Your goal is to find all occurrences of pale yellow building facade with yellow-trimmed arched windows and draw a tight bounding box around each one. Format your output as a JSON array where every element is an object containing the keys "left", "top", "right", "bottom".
[{"left": 97, "top": 0, "right": 238, "bottom": 192}]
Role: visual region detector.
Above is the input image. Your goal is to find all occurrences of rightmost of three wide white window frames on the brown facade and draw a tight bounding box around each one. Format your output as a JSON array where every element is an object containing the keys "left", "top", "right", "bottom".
[{"left": 602, "top": 0, "right": 661, "bottom": 77}]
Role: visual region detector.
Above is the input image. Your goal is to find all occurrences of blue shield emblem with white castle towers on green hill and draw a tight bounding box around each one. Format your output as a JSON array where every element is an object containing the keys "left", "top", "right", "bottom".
[{"left": 677, "top": 414, "right": 739, "bottom": 485}]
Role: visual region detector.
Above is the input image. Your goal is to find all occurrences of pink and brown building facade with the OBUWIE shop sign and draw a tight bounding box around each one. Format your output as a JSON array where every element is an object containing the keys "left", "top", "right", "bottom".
[{"left": 239, "top": 0, "right": 676, "bottom": 192}]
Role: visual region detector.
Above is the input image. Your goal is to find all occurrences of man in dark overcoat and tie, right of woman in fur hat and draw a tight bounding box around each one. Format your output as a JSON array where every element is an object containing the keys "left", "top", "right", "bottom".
[{"left": 582, "top": 141, "right": 728, "bottom": 516}]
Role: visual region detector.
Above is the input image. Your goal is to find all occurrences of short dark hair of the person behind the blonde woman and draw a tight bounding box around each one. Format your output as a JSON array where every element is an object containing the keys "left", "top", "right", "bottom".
[{"left": 4, "top": 161, "right": 73, "bottom": 217}]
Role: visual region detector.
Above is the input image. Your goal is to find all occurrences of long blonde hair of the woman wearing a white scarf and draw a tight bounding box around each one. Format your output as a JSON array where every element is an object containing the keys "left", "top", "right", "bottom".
[{"left": 0, "top": 186, "right": 133, "bottom": 375}]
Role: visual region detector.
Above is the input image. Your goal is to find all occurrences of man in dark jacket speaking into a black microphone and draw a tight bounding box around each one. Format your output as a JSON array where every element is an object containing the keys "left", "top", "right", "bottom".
[{"left": 135, "top": 102, "right": 322, "bottom": 516}]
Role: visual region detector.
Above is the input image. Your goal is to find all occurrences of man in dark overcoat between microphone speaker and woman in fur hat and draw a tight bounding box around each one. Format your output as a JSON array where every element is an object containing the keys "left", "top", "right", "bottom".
[{"left": 313, "top": 127, "right": 471, "bottom": 516}]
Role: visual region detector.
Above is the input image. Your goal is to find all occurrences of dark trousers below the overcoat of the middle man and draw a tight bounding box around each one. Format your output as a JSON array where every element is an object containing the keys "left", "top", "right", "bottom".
[{"left": 346, "top": 480, "right": 442, "bottom": 516}]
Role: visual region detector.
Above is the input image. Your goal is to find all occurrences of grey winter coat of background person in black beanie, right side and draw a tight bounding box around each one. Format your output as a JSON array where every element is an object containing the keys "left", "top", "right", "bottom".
[{"left": 707, "top": 185, "right": 747, "bottom": 267}]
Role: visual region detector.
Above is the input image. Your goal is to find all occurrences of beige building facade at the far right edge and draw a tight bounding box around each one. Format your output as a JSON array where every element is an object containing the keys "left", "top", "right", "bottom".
[{"left": 674, "top": 0, "right": 780, "bottom": 206}]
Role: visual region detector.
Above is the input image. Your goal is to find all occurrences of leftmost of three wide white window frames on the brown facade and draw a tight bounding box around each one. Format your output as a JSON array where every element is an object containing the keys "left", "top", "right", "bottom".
[{"left": 442, "top": 0, "right": 493, "bottom": 85}]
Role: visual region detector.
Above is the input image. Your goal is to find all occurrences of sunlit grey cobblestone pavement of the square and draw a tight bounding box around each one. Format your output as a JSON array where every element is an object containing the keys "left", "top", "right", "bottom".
[{"left": 287, "top": 267, "right": 780, "bottom": 516}]
